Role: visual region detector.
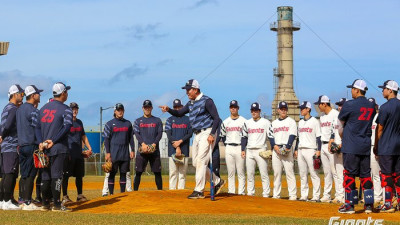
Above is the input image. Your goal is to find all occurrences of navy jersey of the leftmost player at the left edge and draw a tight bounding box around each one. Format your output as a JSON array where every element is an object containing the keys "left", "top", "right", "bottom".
[{"left": 0, "top": 102, "right": 18, "bottom": 152}]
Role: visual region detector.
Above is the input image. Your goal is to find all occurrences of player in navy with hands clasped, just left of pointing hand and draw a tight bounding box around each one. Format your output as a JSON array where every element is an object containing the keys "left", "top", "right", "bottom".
[{"left": 133, "top": 100, "right": 163, "bottom": 191}]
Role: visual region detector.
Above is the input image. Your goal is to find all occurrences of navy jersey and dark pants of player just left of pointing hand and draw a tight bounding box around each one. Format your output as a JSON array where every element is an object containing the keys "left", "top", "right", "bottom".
[{"left": 134, "top": 116, "right": 163, "bottom": 173}]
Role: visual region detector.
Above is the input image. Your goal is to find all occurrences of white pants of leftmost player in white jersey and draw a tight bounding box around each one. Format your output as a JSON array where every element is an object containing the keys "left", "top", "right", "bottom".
[{"left": 225, "top": 145, "right": 245, "bottom": 195}]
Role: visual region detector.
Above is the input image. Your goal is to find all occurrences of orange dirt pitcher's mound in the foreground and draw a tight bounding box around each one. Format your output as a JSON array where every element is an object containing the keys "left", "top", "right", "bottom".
[{"left": 71, "top": 190, "right": 400, "bottom": 221}]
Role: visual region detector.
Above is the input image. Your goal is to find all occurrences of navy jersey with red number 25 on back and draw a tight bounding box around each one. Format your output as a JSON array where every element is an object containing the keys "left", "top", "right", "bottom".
[{"left": 37, "top": 100, "right": 72, "bottom": 156}]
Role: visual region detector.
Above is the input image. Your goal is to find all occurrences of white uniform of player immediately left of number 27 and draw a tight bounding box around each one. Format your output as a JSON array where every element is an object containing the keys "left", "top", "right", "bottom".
[{"left": 320, "top": 109, "right": 344, "bottom": 201}]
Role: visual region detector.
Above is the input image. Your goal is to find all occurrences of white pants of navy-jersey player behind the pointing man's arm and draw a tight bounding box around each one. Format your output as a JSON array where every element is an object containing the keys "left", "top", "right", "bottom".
[{"left": 169, "top": 157, "right": 189, "bottom": 190}]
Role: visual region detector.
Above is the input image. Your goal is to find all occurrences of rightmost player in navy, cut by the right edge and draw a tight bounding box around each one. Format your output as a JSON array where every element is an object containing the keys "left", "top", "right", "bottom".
[{"left": 374, "top": 80, "right": 400, "bottom": 213}]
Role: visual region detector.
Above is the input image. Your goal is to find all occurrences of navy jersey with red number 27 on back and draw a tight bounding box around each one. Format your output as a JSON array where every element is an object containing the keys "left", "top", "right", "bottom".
[{"left": 339, "top": 96, "right": 376, "bottom": 155}]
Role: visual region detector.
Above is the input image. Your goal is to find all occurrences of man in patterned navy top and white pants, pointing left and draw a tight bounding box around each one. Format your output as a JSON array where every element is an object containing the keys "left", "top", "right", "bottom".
[{"left": 159, "top": 79, "right": 225, "bottom": 199}]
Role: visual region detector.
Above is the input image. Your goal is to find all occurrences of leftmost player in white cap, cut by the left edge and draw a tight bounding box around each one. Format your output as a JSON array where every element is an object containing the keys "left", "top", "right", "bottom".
[{"left": 0, "top": 84, "right": 24, "bottom": 210}]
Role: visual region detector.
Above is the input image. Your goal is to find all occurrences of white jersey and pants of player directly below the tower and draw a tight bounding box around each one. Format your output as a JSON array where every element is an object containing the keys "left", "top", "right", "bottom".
[{"left": 272, "top": 117, "right": 297, "bottom": 200}]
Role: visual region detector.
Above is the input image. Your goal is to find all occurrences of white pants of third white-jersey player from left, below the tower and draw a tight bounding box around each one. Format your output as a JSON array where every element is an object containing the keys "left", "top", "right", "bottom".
[{"left": 272, "top": 150, "right": 297, "bottom": 198}]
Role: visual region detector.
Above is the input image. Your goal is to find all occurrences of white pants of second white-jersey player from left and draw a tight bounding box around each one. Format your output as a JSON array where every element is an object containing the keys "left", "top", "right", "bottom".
[{"left": 246, "top": 149, "right": 270, "bottom": 197}]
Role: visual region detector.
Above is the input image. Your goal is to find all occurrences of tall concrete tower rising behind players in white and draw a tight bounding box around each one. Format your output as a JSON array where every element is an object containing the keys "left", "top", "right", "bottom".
[{"left": 270, "top": 6, "right": 300, "bottom": 121}]
